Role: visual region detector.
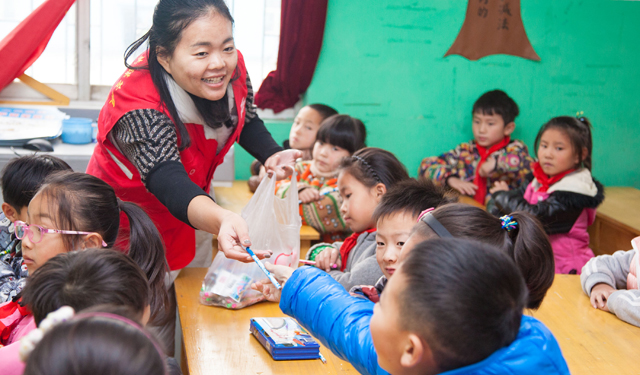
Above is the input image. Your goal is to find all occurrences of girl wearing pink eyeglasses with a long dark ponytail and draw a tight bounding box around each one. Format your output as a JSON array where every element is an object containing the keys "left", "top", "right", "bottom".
[{"left": 0, "top": 172, "right": 170, "bottom": 363}]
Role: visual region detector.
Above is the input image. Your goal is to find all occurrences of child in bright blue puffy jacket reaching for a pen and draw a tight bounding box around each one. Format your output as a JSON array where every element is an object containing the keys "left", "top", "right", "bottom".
[{"left": 255, "top": 238, "right": 569, "bottom": 375}]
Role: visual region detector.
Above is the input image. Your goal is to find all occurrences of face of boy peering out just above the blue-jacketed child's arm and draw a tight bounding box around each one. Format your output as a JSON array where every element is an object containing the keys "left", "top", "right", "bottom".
[{"left": 376, "top": 212, "right": 417, "bottom": 279}]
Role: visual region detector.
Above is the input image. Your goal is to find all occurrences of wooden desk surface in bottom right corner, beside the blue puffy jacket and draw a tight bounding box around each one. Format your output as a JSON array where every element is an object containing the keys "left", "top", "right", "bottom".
[{"left": 528, "top": 275, "right": 640, "bottom": 375}]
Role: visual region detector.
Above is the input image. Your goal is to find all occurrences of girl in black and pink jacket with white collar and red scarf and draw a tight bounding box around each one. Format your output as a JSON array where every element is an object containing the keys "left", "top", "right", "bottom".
[{"left": 487, "top": 115, "right": 604, "bottom": 274}]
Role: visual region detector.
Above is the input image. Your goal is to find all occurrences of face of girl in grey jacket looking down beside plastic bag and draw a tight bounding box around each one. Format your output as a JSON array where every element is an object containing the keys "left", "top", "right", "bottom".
[{"left": 338, "top": 171, "right": 387, "bottom": 232}]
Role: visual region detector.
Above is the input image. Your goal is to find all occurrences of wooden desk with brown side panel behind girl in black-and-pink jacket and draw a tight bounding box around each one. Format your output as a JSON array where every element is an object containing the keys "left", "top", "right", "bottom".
[{"left": 589, "top": 187, "right": 640, "bottom": 255}]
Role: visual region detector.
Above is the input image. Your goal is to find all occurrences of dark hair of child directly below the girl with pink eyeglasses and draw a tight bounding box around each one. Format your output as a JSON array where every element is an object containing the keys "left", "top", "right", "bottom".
[{"left": 22, "top": 249, "right": 149, "bottom": 325}]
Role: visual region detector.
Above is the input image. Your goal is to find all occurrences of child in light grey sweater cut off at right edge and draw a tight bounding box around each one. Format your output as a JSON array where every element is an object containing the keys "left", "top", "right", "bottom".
[{"left": 580, "top": 237, "right": 640, "bottom": 327}]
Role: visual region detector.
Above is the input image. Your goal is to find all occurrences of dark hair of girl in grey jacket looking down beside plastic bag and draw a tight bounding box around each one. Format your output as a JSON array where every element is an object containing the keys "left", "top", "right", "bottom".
[{"left": 340, "top": 147, "right": 410, "bottom": 189}]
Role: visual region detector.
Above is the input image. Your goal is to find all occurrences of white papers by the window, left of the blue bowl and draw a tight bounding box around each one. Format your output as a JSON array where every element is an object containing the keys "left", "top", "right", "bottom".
[{"left": 0, "top": 106, "right": 67, "bottom": 141}]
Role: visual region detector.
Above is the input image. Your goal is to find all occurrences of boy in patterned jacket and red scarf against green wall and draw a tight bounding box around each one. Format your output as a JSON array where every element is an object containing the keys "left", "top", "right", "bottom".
[{"left": 418, "top": 90, "right": 533, "bottom": 204}]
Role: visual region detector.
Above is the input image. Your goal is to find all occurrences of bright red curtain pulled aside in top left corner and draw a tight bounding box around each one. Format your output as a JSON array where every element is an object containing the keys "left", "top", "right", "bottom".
[{"left": 0, "top": 0, "right": 75, "bottom": 90}]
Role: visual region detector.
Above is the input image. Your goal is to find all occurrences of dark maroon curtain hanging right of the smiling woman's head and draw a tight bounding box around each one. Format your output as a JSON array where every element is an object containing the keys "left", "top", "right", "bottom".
[{"left": 256, "top": 0, "right": 328, "bottom": 113}]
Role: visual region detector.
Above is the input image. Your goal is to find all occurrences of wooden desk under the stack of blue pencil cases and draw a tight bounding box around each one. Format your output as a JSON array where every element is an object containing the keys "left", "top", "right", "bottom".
[{"left": 175, "top": 268, "right": 357, "bottom": 375}]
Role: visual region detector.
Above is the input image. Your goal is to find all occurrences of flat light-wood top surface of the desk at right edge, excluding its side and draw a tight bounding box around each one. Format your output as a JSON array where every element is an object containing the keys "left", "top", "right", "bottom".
[{"left": 598, "top": 186, "right": 640, "bottom": 232}]
